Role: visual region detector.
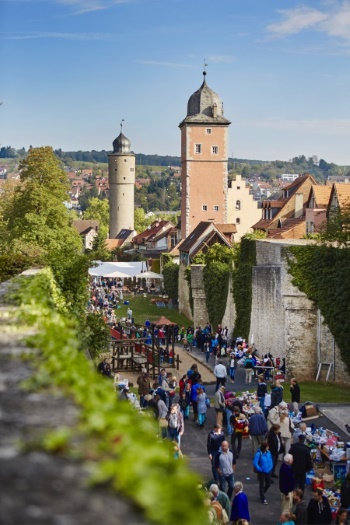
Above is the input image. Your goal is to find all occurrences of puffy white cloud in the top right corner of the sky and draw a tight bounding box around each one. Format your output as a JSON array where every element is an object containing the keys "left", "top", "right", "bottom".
[{"left": 267, "top": 0, "right": 350, "bottom": 42}]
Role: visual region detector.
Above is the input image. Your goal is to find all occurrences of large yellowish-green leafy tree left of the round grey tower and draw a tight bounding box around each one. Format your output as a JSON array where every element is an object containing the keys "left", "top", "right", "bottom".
[{"left": 3, "top": 147, "right": 81, "bottom": 256}]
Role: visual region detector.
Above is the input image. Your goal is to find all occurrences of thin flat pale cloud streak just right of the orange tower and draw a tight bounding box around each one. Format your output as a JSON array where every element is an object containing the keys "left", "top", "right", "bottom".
[{"left": 236, "top": 118, "right": 350, "bottom": 137}]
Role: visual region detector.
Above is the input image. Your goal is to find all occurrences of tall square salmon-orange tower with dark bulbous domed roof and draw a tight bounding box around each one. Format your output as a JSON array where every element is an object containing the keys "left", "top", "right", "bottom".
[{"left": 179, "top": 71, "right": 231, "bottom": 239}]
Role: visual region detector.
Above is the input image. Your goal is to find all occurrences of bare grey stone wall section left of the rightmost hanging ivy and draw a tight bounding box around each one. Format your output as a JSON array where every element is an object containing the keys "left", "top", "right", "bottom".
[{"left": 249, "top": 240, "right": 350, "bottom": 381}]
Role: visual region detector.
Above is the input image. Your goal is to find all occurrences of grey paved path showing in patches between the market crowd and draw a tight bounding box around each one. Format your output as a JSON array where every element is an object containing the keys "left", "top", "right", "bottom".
[{"left": 181, "top": 349, "right": 350, "bottom": 525}]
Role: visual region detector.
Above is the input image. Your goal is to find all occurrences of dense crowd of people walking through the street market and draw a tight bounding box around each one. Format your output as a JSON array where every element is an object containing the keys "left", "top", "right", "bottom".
[{"left": 94, "top": 314, "right": 350, "bottom": 525}]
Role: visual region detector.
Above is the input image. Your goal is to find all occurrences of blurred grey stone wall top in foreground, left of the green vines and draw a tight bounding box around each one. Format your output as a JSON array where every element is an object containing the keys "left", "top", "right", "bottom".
[{"left": 0, "top": 276, "right": 149, "bottom": 525}]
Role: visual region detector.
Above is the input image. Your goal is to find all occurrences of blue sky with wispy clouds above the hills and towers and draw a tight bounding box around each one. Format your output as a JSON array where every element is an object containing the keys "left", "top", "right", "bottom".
[{"left": 0, "top": 0, "right": 350, "bottom": 165}]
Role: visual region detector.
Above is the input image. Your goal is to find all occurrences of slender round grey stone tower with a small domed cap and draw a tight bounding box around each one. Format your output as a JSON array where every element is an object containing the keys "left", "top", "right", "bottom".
[{"left": 108, "top": 126, "right": 135, "bottom": 239}]
